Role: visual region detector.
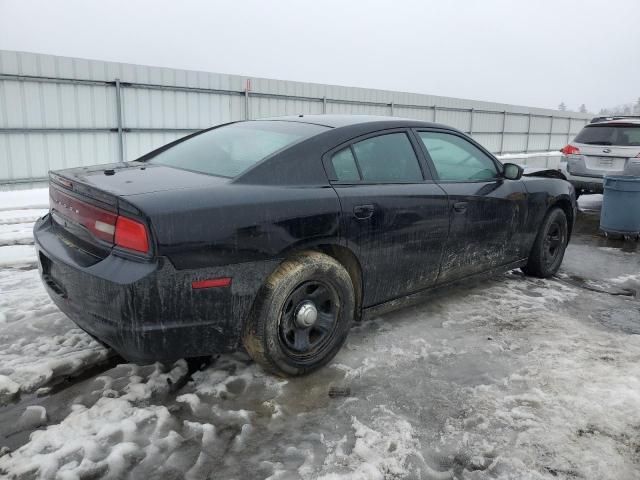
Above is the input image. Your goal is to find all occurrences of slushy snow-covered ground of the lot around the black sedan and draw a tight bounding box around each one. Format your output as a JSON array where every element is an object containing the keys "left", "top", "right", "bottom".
[{"left": 0, "top": 191, "right": 640, "bottom": 480}]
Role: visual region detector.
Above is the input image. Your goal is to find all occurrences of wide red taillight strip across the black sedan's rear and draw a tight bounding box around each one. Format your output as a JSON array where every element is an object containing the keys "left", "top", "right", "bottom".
[{"left": 49, "top": 187, "right": 149, "bottom": 253}]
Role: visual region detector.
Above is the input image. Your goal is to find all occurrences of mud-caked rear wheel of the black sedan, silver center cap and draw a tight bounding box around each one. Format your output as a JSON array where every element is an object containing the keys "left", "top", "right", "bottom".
[{"left": 242, "top": 252, "right": 356, "bottom": 376}]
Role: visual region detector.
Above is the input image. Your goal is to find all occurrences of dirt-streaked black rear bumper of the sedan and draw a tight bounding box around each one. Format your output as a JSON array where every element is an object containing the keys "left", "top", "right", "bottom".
[{"left": 34, "top": 216, "right": 274, "bottom": 363}]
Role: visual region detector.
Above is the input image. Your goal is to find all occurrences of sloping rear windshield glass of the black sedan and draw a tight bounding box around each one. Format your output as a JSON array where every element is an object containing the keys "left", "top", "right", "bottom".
[{"left": 149, "top": 121, "right": 328, "bottom": 177}]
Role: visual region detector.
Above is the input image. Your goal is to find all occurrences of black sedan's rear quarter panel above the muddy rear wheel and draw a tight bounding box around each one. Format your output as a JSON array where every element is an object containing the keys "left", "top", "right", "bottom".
[{"left": 127, "top": 183, "right": 340, "bottom": 269}]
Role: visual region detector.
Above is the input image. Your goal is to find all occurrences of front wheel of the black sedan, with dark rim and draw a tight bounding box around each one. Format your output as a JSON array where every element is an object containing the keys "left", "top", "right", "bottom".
[{"left": 522, "top": 207, "right": 569, "bottom": 278}]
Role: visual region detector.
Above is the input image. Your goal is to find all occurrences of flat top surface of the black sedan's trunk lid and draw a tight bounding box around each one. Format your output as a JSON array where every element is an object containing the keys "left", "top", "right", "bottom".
[{"left": 53, "top": 162, "right": 230, "bottom": 197}]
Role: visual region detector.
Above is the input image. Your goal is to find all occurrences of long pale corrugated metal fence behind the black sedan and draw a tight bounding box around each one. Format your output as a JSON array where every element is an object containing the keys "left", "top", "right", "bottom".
[{"left": 0, "top": 50, "right": 589, "bottom": 183}]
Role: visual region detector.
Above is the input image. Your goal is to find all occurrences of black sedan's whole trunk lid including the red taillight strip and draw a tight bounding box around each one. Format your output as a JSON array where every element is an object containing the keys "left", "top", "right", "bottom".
[{"left": 49, "top": 162, "right": 226, "bottom": 261}]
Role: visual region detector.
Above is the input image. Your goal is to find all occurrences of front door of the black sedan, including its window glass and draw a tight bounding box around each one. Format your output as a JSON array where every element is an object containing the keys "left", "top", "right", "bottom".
[{"left": 416, "top": 129, "right": 527, "bottom": 283}]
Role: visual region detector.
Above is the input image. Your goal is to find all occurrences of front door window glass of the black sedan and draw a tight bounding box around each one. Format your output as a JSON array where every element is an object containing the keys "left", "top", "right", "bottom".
[{"left": 418, "top": 132, "right": 498, "bottom": 182}]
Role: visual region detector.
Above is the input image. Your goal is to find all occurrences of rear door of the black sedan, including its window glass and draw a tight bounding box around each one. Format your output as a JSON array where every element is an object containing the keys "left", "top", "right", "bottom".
[{"left": 325, "top": 129, "right": 449, "bottom": 307}]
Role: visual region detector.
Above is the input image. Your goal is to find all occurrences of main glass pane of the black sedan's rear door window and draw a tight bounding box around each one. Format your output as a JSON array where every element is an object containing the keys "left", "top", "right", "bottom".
[{"left": 353, "top": 133, "right": 423, "bottom": 183}]
